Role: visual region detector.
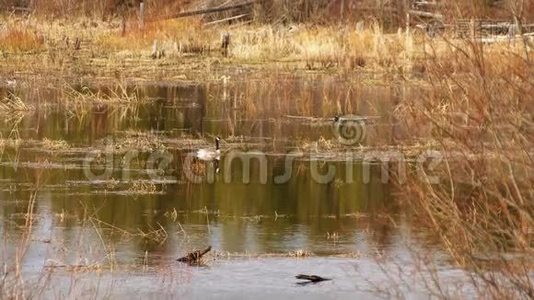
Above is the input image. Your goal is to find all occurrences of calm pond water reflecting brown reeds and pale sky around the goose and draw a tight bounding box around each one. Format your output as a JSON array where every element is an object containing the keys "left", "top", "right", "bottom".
[{"left": 0, "top": 74, "right": 478, "bottom": 299}]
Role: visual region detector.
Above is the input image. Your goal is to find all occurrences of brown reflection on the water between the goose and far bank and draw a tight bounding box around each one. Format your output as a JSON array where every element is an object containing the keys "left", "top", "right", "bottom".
[{"left": 0, "top": 78, "right": 410, "bottom": 143}]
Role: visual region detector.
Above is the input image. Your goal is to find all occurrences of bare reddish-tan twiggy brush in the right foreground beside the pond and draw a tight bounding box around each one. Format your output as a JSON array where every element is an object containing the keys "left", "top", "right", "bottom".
[{"left": 398, "top": 33, "right": 534, "bottom": 298}]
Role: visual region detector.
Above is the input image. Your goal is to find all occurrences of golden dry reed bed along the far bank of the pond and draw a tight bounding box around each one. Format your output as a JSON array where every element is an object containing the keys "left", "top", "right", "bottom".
[{"left": 0, "top": 17, "right": 524, "bottom": 78}]
